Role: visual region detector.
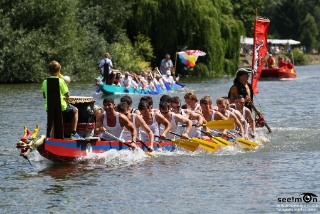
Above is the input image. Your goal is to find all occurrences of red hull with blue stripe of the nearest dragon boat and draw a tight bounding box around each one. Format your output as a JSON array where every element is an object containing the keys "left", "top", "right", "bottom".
[{"left": 37, "top": 138, "right": 175, "bottom": 162}]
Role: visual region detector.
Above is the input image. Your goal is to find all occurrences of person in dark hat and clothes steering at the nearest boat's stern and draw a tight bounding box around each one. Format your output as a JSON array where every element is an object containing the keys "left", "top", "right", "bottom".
[{"left": 228, "top": 68, "right": 253, "bottom": 111}]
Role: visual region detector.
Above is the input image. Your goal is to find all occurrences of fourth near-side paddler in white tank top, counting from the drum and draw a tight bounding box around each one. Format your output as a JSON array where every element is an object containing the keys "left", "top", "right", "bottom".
[{"left": 159, "top": 102, "right": 192, "bottom": 139}]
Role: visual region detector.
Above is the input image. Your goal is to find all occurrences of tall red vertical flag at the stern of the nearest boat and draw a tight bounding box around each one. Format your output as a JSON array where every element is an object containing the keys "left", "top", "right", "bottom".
[{"left": 251, "top": 17, "right": 270, "bottom": 94}]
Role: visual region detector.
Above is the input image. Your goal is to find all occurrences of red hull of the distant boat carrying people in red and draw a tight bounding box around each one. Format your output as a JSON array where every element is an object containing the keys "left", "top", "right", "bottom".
[{"left": 260, "top": 67, "right": 297, "bottom": 79}]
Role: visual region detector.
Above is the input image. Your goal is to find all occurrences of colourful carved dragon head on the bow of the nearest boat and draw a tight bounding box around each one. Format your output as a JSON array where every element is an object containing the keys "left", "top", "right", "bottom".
[{"left": 16, "top": 125, "right": 45, "bottom": 156}]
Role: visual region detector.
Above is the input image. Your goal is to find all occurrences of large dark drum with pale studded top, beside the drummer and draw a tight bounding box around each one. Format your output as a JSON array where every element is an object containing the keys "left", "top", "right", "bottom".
[{"left": 63, "top": 96, "right": 95, "bottom": 138}]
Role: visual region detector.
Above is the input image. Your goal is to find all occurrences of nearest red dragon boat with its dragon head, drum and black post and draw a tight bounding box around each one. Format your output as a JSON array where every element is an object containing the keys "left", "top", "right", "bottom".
[{"left": 16, "top": 78, "right": 175, "bottom": 162}]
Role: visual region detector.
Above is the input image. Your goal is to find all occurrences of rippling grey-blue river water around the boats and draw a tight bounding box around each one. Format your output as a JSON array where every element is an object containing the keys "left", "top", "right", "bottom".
[{"left": 0, "top": 65, "right": 320, "bottom": 213}]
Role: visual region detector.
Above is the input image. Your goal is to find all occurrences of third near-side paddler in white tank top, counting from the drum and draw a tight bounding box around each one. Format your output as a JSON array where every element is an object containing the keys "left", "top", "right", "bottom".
[{"left": 138, "top": 101, "right": 171, "bottom": 141}]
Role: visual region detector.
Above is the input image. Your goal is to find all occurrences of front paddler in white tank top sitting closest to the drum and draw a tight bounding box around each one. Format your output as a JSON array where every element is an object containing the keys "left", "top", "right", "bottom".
[{"left": 94, "top": 97, "right": 137, "bottom": 149}]
